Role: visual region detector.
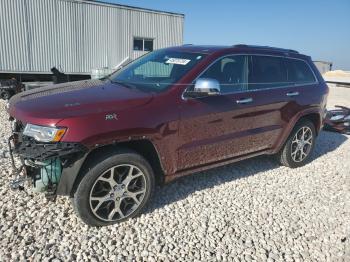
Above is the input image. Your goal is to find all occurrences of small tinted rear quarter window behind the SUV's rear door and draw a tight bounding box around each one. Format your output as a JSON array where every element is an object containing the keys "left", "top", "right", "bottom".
[{"left": 286, "top": 59, "right": 316, "bottom": 84}]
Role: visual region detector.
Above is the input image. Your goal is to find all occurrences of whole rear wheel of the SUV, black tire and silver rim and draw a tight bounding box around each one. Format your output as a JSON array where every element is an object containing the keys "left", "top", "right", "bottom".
[{"left": 277, "top": 119, "right": 316, "bottom": 168}]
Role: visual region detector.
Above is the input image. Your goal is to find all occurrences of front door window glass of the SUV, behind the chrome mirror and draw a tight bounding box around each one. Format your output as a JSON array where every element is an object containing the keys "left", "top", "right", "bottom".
[{"left": 200, "top": 55, "right": 248, "bottom": 94}]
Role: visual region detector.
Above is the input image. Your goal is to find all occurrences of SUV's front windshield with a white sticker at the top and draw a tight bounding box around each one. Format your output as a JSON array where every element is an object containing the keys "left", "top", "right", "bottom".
[{"left": 109, "top": 50, "right": 205, "bottom": 92}]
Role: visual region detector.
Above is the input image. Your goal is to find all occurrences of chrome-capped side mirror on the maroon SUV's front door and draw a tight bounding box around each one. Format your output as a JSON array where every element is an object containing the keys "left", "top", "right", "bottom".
[{"left": 186, "top": 78, "right": 220, "bottom": 98}]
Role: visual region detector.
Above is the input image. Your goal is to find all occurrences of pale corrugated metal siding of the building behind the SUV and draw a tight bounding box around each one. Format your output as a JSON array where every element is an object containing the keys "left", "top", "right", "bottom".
[{"left": 0, "top": 0, "right": 184, "bottom": 73}]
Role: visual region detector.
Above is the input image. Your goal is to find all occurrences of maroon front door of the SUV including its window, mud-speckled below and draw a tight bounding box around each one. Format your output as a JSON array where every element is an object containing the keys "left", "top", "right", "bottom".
[{"left": 177, "top": 55, "right": 255, "bottom": 170}]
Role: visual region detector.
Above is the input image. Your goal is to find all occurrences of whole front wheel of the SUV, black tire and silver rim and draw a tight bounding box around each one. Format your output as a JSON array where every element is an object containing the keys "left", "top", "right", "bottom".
[{"left": 73, "top": 150, "right": 155, "bottom": 226}]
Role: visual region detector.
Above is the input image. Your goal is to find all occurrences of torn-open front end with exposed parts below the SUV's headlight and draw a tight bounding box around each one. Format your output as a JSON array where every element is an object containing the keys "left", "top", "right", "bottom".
[{"left": 8, "top": 123, "right": 88, "bottom": 199}]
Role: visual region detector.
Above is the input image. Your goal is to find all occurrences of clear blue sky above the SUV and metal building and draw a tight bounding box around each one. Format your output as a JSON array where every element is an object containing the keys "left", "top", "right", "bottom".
[{"left": 106, "top": 0, "right": 350, "bottom": 70}]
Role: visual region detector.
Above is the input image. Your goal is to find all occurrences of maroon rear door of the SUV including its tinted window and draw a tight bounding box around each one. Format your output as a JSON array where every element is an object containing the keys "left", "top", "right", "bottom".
[{"left": 243, "top": 54, "right": 296, "bottom": 152}]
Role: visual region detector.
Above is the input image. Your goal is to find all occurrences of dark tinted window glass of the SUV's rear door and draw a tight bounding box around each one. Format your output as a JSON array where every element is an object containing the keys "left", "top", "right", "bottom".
[{"left": 248, "top": 56, "right": 291, "bottom": 90}]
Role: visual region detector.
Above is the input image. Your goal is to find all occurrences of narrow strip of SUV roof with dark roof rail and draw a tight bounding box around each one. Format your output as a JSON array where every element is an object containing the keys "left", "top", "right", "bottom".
[{"left": 165, "top": 44, "right": 301, "bottom": 55}]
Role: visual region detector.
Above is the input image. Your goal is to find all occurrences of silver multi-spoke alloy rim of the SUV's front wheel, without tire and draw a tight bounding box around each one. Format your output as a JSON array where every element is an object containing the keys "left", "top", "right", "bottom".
[{"left": 89, "top": 164, "right": 147, "bottom": 222}]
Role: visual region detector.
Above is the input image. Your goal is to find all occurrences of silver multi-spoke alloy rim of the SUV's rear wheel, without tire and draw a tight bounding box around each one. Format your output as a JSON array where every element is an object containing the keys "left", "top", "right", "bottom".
[{"left": 291, "top": 126, "right": 313, "bottom": 162}]
